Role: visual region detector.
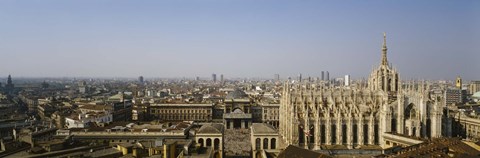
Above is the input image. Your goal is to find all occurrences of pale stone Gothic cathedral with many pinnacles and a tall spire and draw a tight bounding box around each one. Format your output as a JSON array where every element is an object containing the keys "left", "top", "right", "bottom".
[{"left": 279, "top": 34, "right": 452, "bottom": 150}]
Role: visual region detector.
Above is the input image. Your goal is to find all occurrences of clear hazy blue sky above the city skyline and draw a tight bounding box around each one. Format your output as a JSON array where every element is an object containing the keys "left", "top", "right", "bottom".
[{"left": 0, "top": 0, "right": 480, "bottom": 80}]
